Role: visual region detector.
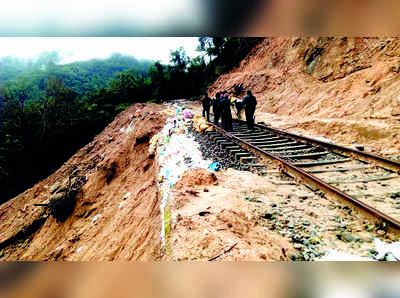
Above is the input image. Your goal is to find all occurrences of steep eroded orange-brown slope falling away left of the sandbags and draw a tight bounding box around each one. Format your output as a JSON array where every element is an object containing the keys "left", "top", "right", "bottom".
[{"left": 0, "top": 105, "right": 165, "bottom": 261}]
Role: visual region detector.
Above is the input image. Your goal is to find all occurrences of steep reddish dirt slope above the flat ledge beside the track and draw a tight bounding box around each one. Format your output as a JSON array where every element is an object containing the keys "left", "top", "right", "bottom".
[{"left": 208, "top": 37, "right": 400, "bottom": 117}]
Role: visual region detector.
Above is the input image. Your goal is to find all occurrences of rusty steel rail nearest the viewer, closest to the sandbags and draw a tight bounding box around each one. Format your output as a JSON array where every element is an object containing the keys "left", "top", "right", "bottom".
[{"left": 210, "top": 123, "right": 400, "bottom": 229}]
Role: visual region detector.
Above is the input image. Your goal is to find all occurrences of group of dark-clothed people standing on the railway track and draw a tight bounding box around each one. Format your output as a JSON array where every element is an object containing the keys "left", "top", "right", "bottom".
[{"left": 202, "top": 90, "right": 257, "bottom": 131}]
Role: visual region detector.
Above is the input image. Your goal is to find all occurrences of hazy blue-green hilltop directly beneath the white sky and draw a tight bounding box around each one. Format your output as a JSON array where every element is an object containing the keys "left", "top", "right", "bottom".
[{"left": 0, "top": 52, "right": 152, "bottom": 99}]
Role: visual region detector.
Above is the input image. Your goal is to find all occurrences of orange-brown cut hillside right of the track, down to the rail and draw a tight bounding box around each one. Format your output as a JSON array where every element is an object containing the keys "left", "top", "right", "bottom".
[{"left": 209, "top": 37, "right": 400, "bottom": 158}]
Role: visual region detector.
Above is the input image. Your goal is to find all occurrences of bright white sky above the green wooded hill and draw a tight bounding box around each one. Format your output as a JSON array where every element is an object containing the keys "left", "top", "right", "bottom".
[{"left": 0, "top": 37, "right": 200, "bottom": 64}]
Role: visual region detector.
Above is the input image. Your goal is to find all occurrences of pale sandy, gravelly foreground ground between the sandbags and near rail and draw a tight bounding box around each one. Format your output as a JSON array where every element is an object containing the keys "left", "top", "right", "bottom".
[{"left": 169, "top": 103, "right": 400, "bottom": 261}]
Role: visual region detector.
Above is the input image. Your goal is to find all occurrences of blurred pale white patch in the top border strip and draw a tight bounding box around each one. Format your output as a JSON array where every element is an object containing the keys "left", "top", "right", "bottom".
[{"left": 0, "top": 0, "right": 205, "bottom": 36}]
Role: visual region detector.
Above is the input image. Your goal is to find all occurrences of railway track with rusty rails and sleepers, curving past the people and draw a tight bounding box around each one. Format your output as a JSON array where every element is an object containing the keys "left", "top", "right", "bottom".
[{"left": 206, "top": 120, "right": 400, "bottom": 229}]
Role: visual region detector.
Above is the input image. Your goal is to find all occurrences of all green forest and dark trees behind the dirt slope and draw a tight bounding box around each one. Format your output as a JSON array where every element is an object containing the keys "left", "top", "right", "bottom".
[{"left": 0, "top": 38, "right": 260, "bottom": 203}]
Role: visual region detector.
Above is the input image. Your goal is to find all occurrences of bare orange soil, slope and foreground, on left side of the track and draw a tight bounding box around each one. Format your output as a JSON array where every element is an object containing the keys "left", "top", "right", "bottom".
[{"left": 0, "top": 99, "right": 400, "bottom": 262}]
